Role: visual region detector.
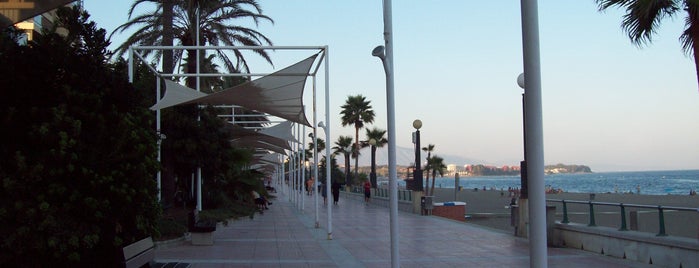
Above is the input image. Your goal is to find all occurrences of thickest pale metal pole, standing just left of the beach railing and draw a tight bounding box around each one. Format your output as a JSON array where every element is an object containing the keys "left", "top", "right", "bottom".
[{"left": 521, "top": 0, "right": 548, "bottom": 268}]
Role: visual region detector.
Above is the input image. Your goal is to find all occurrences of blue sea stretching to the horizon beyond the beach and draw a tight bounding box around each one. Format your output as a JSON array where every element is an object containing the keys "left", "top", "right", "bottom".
[{"left": 398, "top": 170, "right": 699, "bottom": 195}]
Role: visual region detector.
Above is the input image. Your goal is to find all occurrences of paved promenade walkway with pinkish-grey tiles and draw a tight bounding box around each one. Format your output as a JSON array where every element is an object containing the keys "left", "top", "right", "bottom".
[{"left": 155, "top": 189, "right": 650, "bottom": 268}]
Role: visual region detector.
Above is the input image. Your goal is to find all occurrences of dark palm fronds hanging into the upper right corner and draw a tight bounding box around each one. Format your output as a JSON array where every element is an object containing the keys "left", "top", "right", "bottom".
[{"left": 596, "top": 0, "right": 699, "bottom": 87}]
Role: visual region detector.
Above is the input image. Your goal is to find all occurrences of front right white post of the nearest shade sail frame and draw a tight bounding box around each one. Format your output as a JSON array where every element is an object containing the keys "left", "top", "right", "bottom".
[{"left": 325, "top": 46, "right": 333, "bottom": 240}]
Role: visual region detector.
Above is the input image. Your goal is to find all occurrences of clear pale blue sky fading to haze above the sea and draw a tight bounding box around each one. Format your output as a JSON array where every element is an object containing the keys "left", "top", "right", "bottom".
[{"left": 84, "top": 0, "right": 699, "bottom": 172}]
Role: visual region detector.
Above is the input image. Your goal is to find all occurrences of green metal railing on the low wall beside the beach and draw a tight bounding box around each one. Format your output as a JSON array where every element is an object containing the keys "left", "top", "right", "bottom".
[{"left": 546, "top": 199, "right": 699, "bottom": 236}]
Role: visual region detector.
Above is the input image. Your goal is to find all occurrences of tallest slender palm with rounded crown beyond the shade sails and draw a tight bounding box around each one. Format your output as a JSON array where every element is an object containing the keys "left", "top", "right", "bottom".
[{"left": 340, "top": 94, "right": 374, "bottom": 182}]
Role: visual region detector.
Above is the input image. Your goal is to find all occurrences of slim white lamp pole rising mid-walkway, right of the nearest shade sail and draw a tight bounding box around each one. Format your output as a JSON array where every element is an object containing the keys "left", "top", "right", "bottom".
[{"left": 383, "top": 0, "right": 400, "bottom": 268}]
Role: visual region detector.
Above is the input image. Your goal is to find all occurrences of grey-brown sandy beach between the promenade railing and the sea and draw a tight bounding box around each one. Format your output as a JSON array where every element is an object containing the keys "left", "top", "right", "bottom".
[{"left": 434, "top": 188, "right": 699, "bottom": 238}]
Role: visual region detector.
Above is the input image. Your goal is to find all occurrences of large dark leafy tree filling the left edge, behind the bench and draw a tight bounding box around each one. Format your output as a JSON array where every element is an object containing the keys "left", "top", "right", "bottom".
[{"left": 0, "top": 8, "right": 160, "bottom": 267}]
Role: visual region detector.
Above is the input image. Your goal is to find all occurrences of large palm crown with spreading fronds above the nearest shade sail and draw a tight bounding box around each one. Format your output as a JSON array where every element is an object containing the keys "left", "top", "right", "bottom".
[{"left": 112, "top": 0, "right": 274, "bottom": 86}]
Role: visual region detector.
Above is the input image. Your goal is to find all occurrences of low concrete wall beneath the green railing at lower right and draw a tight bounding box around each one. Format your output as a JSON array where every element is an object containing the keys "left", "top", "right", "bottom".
[{"left": 549, "top": 223, "right": 699, "bottom": 267}]
